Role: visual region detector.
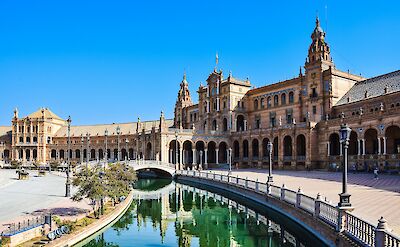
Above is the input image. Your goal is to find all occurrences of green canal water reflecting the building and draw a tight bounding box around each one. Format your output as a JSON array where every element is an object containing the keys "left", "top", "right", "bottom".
[{"left": 83, "top": 179, "right": 324, "bottom": 247}]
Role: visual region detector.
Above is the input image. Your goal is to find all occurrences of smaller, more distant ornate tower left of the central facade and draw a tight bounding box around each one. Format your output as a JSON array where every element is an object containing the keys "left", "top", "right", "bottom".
[{"left": 174, "top": 73, "right": 193, "bottom": 128}]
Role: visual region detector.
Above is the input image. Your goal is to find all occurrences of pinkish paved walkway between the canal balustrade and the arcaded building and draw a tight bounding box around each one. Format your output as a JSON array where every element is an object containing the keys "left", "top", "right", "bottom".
[{"left": 213, "top": 169, "right": 400, "bottom": 235}]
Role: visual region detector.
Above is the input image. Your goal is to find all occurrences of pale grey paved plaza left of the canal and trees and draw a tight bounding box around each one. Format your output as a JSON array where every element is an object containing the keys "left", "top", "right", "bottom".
[{"left": 0, "top": 170, "right": 90, "bottom": 232}]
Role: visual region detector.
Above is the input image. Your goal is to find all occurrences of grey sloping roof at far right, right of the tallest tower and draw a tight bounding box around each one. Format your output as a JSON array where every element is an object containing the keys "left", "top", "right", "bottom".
[{"left": 336, "top": 70, "right": 400, "bottom": 106}]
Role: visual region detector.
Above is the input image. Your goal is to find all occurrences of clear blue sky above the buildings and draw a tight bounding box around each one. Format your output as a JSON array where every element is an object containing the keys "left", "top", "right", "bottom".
[{"left": 0, "top": 0, "right": 400, "bottom": 125}]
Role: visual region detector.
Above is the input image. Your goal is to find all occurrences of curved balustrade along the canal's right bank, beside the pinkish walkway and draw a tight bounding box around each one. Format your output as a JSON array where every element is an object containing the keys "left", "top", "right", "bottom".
[{"left": 176, "top": 170, "right": 400, "bottom": 247}]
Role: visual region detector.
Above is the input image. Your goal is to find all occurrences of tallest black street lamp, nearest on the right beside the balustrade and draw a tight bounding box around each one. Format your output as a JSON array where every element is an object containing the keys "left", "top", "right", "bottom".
[{"left": 339, "top": 123, "right": 351, "bottom": 207}]
